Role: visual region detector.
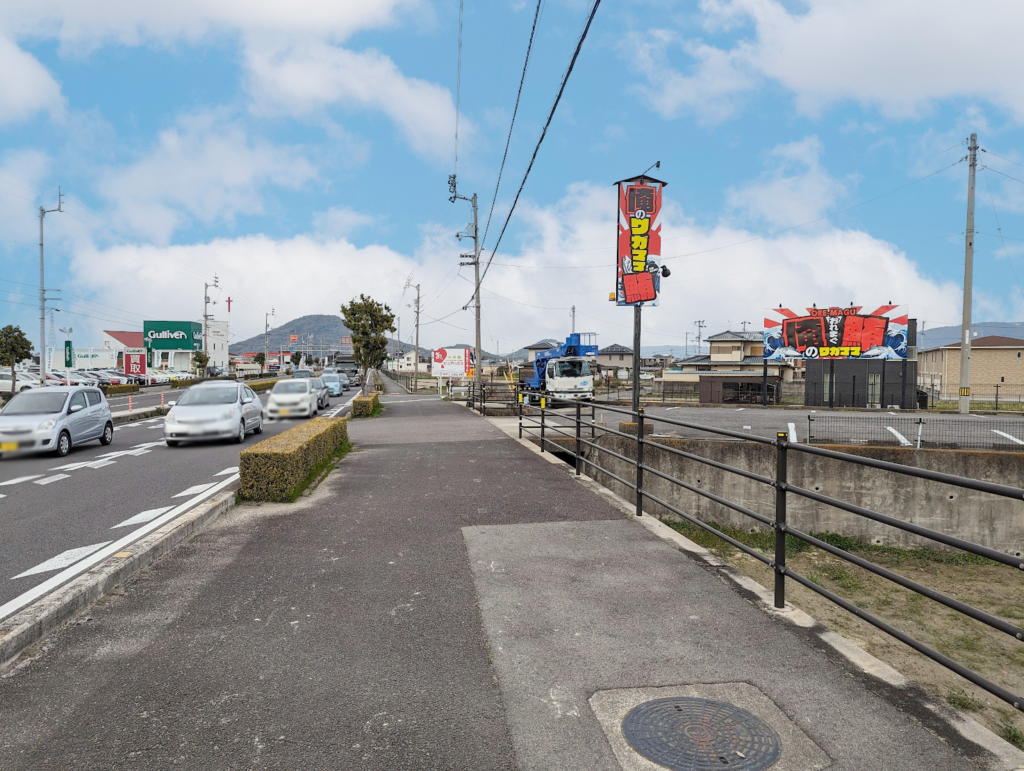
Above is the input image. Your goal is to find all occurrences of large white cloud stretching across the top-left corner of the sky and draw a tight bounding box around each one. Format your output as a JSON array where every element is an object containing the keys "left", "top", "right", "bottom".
[{"left": 0, "top": 0, "right": 458, "bottom": 157}]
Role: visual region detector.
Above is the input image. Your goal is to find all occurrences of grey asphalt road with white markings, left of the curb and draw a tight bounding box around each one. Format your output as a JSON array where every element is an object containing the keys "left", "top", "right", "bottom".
[{"left": 0, "top": 390, "right": 356, "bottom": 618}]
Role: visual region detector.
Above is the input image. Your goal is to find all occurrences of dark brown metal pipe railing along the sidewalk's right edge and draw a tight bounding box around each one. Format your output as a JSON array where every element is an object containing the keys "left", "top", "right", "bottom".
[{"left": 517, "top": 384, "right": 1024, "bottom": 712}]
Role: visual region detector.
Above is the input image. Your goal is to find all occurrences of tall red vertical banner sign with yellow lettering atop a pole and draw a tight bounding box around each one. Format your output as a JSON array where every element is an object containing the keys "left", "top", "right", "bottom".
[{"left": 615, "top": 176, "right": 665, "bottom": 305}]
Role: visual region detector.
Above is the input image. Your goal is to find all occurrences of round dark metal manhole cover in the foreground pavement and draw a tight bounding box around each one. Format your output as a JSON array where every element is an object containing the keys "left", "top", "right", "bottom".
[{"left": 623, "top": 696, "right": 782, "bottom": 771}]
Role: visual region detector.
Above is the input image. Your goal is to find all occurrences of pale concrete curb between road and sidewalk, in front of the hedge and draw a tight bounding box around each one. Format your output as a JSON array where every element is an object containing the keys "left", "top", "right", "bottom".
[{"left": 0, "top": 483, "right": 238, "bottom": 672}]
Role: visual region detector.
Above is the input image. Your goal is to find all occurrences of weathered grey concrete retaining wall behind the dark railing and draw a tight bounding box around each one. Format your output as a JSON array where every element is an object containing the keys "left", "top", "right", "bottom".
[{"left": 585, "top": 435, "right": 1024, "bottom": 556}]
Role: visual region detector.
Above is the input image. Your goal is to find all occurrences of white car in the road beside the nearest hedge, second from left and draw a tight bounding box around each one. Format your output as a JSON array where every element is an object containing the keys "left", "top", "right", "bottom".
[{"left": 164, "top": 382, "right": 263, "bottom": 447}]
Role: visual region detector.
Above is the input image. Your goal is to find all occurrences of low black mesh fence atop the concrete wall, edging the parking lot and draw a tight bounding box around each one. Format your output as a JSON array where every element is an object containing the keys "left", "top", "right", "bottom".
[{"left": 806, "top": 415, "right": 1024, "bottom": 453}]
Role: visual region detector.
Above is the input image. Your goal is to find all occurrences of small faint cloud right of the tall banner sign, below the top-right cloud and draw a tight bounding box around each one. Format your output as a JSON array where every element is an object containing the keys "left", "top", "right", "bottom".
[{"left": 727, "top": 136, "right": 846, "bottom": 227}]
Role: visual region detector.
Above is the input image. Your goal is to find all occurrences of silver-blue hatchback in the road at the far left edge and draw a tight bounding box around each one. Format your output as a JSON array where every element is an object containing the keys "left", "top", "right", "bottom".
[{"left": 0, "top": 386, "right": 114, "bottom": 457}]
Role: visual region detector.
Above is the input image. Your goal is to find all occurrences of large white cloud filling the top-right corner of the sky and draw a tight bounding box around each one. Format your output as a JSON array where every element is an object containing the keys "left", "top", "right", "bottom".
[{"left": 630, "top": 0, "right": 1024, "bottom": 121}]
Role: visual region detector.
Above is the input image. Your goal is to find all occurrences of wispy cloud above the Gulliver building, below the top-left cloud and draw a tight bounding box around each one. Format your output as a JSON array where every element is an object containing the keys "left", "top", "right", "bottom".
[{"left": 98, "top": 113, "right": 316, "bottom": 242}]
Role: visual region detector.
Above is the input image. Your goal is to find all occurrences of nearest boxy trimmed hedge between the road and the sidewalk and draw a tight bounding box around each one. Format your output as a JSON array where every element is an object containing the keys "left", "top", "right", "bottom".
[{"left": 239, "top": 418, "right": 348, "bottom": 502}]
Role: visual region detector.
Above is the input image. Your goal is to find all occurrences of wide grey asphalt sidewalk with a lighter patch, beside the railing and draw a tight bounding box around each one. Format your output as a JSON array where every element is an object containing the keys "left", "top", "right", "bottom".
[{"left": 0, "top": 388, "right": 1011, "bottom": 770}]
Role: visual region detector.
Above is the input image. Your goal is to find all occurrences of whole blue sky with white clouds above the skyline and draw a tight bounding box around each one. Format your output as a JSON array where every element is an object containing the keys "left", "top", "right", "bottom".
[{"left": 0, "top": 0, "right": 1024, "bottom": 351}]
